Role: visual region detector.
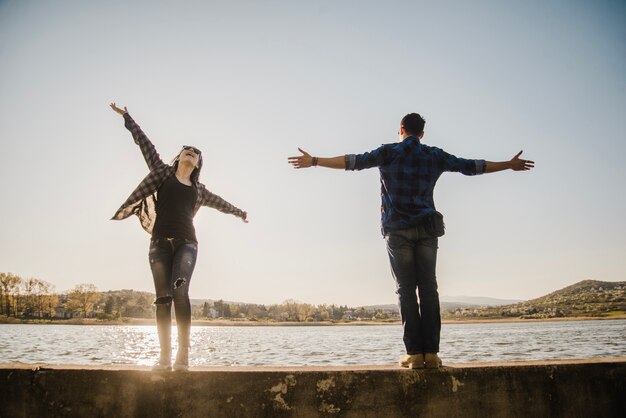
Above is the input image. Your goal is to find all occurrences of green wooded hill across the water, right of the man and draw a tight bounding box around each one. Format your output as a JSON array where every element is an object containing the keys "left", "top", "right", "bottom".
[{"left": 443, "top": 280, "right": 626, "bottom": 319}]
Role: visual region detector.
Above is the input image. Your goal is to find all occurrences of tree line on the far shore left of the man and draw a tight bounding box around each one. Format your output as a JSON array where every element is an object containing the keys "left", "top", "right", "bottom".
[{"left": 0, "top": 273, "right": 397, "bottom": 322}]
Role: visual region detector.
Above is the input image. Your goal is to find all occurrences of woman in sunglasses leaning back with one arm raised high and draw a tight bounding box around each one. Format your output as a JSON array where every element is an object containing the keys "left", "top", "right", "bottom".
[{"left": 111, "top": 103, "right": 248, "bottom": 371}]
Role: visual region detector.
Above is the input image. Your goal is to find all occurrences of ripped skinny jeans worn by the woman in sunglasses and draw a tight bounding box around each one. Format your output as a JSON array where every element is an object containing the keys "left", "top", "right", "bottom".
[{"left": 149, "top": 238, "right": 198, "bottom": 360}]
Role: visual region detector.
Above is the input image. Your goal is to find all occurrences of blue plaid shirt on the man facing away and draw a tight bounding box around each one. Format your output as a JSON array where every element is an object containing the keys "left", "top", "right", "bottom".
[{"left": 345, "top": 136, "right": 485, "bottom": 235}]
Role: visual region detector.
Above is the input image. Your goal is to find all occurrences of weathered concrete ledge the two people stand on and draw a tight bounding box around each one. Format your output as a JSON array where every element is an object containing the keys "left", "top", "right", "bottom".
[{"left": 0, "top": 357, "right": 626, "bottom": 418}]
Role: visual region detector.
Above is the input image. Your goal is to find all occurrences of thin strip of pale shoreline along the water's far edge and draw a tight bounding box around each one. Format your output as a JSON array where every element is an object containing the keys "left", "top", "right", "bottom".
[{"left": 0, "top": 315, "right": 626, "bottom": 327}]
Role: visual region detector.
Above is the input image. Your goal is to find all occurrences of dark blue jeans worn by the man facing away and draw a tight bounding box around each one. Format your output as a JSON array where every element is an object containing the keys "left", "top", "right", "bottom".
[{"left": 385, "top": 226, "right": 441, "bottom": 354}]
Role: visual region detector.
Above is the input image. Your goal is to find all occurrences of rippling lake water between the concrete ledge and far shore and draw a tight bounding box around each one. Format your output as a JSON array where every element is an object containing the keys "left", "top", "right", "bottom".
[{"left": 0, "top": 320, "right": 626, "bottom": 366}]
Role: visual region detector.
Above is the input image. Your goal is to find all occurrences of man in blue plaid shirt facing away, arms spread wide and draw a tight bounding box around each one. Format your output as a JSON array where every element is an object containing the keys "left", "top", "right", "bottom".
[{"left": 288, "top": 113, "right": 535, "bottom": 369}]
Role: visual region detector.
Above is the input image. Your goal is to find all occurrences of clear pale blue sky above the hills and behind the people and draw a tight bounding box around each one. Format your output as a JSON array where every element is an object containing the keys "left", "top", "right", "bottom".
[{"left": 0, "top": 0, "right": 626, "bottom": 306}]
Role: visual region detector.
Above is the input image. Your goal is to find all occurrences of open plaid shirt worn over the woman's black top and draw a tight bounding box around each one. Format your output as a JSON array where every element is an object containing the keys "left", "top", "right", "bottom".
[{"left": 111, "top": 113, "right": 247, "bottom": 234}]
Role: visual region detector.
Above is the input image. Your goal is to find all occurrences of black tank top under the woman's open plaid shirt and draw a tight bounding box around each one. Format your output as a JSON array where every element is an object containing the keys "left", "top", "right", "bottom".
[{"left": 152, "top": 175, "right": 198, "bottom": 242}]
